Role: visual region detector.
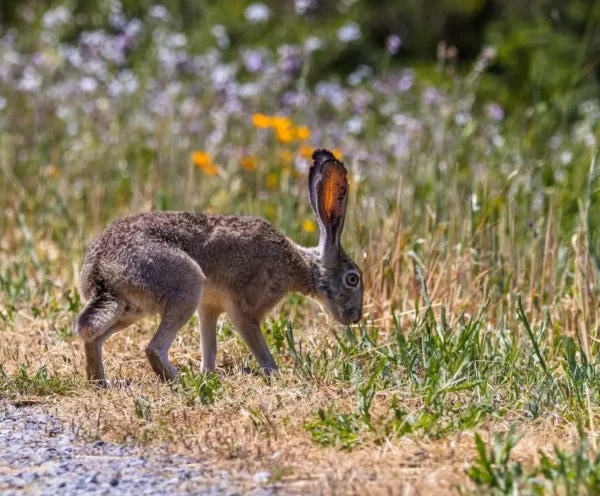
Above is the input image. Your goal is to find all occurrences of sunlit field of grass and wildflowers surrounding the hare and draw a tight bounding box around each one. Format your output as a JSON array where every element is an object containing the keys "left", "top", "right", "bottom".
[{"left": 0, "top": 5, "right": 600, "bottom": 494}]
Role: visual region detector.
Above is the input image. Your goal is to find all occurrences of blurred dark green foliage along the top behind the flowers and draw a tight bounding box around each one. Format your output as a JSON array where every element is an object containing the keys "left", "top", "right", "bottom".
[{"left": 0, "top": 0, "right": 600, "bottom": 111}]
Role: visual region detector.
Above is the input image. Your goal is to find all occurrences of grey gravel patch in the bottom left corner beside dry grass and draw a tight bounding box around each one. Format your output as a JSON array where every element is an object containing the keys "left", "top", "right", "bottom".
[{"left": 0, "top": 404, "right": 281, "bottom": 496}]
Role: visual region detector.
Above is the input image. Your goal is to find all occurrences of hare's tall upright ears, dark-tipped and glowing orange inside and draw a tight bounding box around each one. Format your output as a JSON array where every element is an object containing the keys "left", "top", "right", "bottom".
[{"left": 308, "top": 150, "right": 348, "bottom": 259}]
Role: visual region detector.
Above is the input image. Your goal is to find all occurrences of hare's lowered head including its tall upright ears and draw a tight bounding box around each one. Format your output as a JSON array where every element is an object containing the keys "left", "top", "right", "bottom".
[{"left": 308, "top": 150, "right": 363, "bottom": 324}]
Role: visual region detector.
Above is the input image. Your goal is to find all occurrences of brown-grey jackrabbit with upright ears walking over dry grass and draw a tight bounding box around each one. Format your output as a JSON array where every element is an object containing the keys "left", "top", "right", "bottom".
[{"left": 76, "top": 150, "right": 363, "bottom": 387}]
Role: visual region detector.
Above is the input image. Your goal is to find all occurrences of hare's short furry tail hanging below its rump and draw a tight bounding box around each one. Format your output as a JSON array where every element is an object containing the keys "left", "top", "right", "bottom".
[{"left": 75, "top": 293, "right": 125, "bottom": 343}]
